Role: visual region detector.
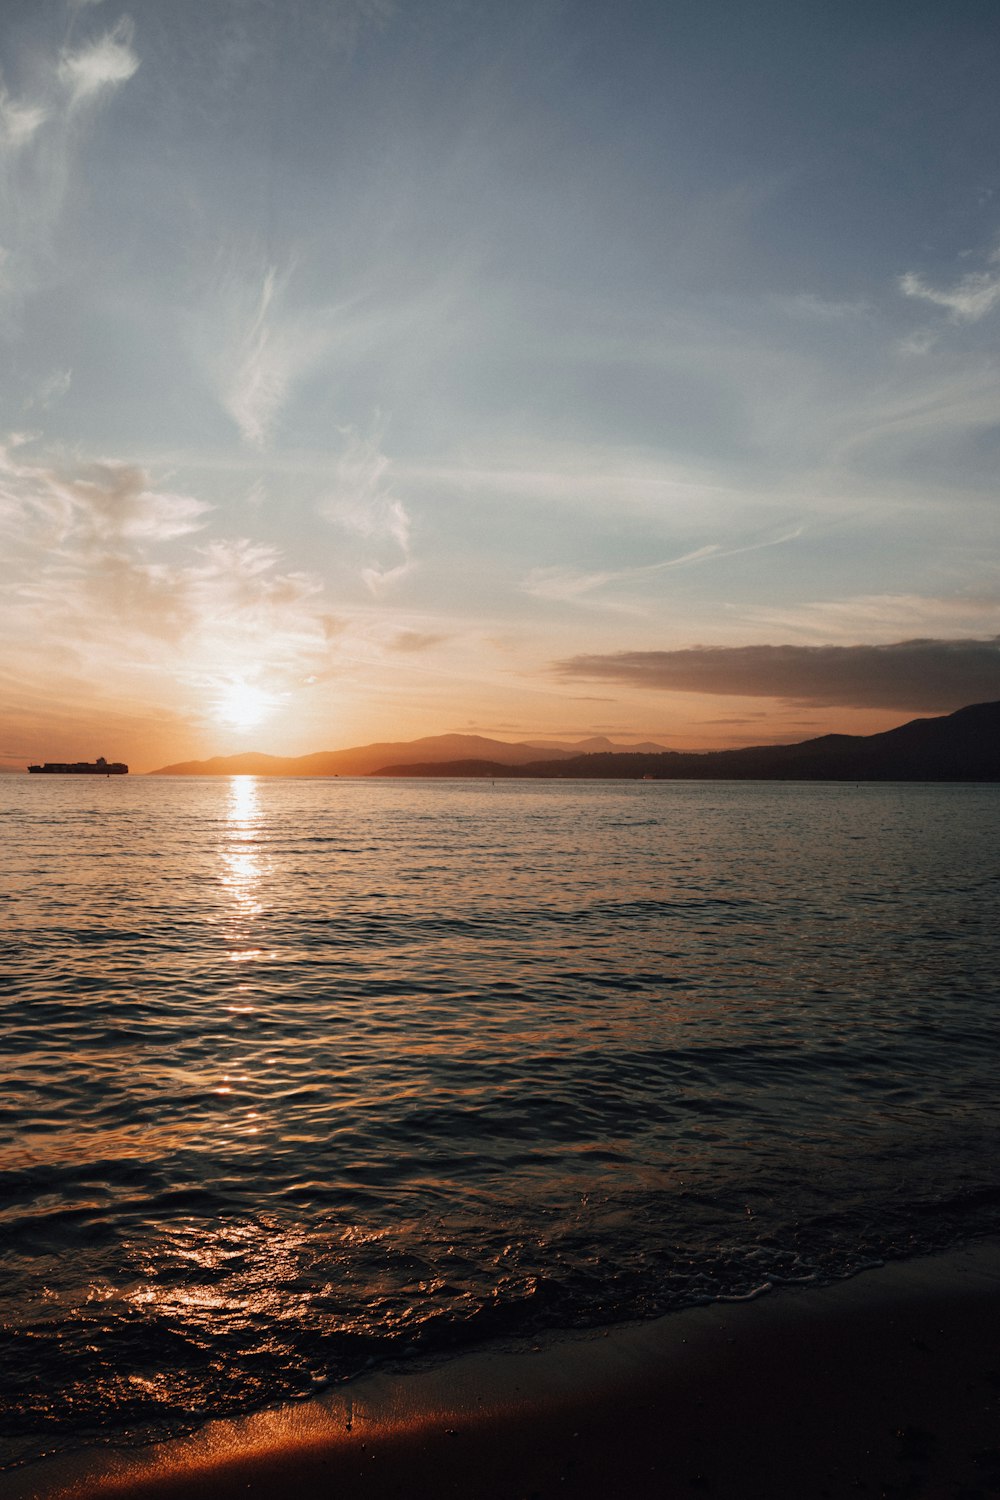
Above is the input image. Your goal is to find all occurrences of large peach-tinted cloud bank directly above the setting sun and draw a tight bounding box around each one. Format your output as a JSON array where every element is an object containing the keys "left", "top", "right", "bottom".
[{"left": 0, "top": 447, "right": 330, "bottom": 686}]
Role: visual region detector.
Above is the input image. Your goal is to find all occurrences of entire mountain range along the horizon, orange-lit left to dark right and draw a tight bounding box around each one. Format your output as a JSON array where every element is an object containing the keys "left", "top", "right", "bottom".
[{"left": 150, "top": 702, "right": 1000, "bottom": 782}]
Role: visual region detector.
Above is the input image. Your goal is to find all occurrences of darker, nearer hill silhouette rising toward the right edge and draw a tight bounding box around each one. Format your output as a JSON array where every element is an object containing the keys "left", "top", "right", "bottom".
[{"left": 376, "top": 704, "right": 1000, "bottom": 782}]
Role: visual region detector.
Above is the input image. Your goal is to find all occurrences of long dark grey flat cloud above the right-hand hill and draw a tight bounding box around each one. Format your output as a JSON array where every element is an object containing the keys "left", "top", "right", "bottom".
[{"left": 555, "top": 636, "right": 1000, "bottom": 713}]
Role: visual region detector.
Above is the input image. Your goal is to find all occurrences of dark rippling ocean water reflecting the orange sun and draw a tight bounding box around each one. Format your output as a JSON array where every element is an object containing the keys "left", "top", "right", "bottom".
[{"left": 0, "top": 776, "right": 1000, "bottom": 1464}]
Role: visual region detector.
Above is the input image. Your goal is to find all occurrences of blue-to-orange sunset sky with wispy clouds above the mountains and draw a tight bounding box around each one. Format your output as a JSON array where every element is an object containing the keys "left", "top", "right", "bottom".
[{"left": 0, "top": 0, "right": 1000, "bottom": 771}]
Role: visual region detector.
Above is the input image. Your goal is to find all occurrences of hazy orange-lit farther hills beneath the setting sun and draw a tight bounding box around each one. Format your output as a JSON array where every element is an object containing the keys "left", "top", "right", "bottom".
[{"left": 150, "top": 735, "right": 663, "bottom": 776}]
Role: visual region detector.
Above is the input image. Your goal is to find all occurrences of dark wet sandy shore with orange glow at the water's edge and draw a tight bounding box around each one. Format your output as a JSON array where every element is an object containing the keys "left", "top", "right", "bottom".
[{"left": 7, "top": 1241, "right": 1000, "bottom": 1500}]
